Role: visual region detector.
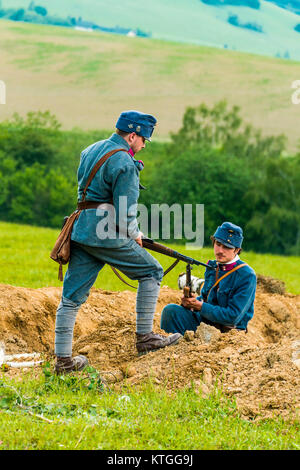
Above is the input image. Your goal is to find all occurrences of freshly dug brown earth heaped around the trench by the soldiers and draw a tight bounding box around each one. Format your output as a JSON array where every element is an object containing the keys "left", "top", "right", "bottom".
[{"left": 0, "top": 278, "right": 300, "bottom": 419}]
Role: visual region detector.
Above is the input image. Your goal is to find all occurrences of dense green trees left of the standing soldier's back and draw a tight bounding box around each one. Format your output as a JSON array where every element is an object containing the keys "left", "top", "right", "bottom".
[{"left": 0, "top": 112, "right": 109, "bottom": 227}]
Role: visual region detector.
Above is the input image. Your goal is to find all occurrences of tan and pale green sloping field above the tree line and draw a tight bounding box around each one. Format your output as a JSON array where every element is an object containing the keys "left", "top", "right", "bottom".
[{"left": 0, "top": 21, "right": 300, "bottom": 150}]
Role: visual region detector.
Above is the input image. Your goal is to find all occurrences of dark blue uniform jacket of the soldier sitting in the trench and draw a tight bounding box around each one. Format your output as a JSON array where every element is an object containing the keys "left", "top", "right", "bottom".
[{"left": 195, "top": 260, "right": 256, "bottom": 329}]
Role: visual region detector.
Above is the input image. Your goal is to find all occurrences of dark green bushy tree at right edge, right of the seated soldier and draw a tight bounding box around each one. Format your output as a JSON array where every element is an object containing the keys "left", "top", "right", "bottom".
[{"left": 246, "top": 155, "right": 300, "bottom": 255}]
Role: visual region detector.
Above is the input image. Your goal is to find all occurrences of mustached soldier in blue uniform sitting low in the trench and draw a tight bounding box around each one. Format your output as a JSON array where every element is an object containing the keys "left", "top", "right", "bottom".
[{"left": 161, "top": 222, "right": 256, "bottom": 335}]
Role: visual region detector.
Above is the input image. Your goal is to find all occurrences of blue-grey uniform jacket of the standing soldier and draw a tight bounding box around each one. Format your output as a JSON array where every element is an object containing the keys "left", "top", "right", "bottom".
[{"left": 71, "top": 133, "right": 142, "bottom": 248}]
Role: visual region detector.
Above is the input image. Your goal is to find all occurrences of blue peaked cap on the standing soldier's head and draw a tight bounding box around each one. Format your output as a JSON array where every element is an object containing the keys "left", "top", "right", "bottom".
[{"left": 116, "top": 111, "right": 157, "bottom": 141}]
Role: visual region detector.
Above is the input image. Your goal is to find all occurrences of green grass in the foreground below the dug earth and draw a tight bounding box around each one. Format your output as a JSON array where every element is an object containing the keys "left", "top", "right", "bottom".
[{"left": 0, "top": 367, "right": 300, "bottom": 450}]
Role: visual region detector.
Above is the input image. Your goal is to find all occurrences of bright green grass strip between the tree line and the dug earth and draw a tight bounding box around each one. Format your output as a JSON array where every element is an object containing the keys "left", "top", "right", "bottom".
[{"left": 0, "top": 222, "right": 300, "bottom": 294}]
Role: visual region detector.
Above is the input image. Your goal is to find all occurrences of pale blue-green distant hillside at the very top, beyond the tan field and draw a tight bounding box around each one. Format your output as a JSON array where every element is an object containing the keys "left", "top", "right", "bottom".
[{"left": 2, "top": 0, "right": 300, "bottom": 60}]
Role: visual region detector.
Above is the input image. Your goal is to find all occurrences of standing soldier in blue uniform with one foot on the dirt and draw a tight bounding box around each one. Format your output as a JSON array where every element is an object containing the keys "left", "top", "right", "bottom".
[{"left": 55, "top": 111, "right": 181, "bottom": 374}]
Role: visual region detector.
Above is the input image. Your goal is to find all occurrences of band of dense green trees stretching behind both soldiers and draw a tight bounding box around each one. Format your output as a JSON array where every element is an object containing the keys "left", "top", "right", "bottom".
[{"left": 0, "top": 101, "right": 300, "bottom": 255}]
